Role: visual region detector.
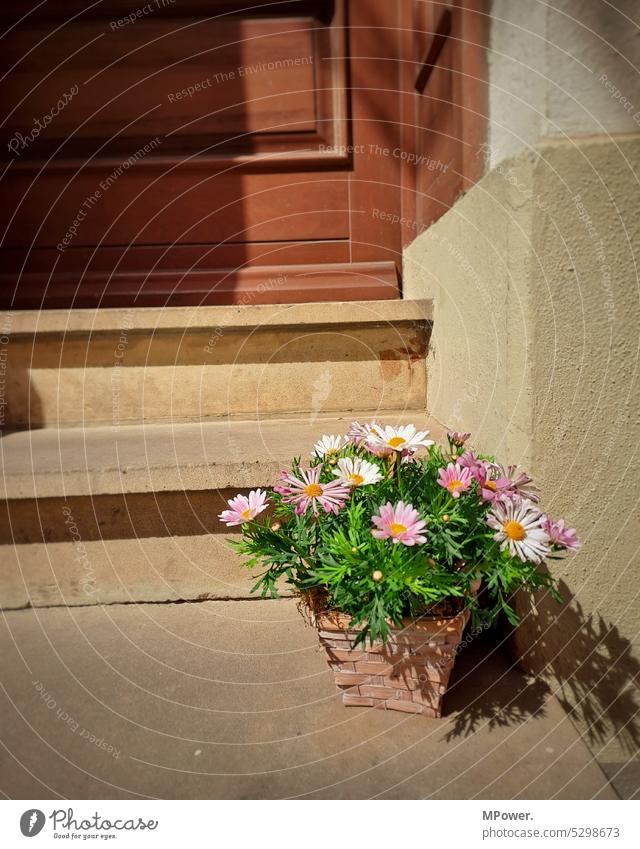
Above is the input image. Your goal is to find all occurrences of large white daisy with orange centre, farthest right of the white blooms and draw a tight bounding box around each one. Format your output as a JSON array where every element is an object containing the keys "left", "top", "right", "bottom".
[{"left": 487, "top": 498, "right": 549, "bottom": 563}]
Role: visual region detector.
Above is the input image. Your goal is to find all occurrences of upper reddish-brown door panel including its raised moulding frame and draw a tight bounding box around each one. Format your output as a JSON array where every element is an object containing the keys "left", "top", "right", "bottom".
[{"left": 0, "top": 9, "right": 347, "bottom": 161}]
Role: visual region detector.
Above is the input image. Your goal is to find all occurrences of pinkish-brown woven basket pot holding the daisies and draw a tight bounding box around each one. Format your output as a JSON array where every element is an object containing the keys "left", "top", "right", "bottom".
[{"left": 303, "top": 598, "right": 469, "bottom": 718}]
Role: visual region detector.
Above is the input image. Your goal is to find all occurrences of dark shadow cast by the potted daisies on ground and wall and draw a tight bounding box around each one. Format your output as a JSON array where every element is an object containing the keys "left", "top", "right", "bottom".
[{"left": 445, "top": 581, "right": 640, "bottom": 758}]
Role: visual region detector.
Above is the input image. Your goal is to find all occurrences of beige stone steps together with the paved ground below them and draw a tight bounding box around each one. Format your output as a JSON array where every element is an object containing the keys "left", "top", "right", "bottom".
[{"left": 0, "top": 301, "right": 615, "bottom": 799}]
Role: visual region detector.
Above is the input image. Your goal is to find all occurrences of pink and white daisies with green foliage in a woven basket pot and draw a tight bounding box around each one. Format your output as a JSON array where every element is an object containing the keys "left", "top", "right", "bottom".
[{"left": 220, "top": 422, "right": 580, "bottom": 717}]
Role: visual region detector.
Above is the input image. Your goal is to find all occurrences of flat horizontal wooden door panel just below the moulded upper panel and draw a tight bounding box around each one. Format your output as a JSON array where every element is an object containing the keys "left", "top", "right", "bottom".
[{"left": 0, "top": 165, "right": 349, "bottom": 243}]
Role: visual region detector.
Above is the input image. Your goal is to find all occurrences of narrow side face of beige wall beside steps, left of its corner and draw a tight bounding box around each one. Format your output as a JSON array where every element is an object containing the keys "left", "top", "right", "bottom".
[{"left": 404, "top": 146, "right": 534, "bottom": 461}]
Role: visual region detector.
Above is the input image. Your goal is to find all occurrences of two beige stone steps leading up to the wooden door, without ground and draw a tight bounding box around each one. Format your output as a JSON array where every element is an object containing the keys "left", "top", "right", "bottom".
[{"left": 0, "top": 301, "right": 431, "bottom": 609}]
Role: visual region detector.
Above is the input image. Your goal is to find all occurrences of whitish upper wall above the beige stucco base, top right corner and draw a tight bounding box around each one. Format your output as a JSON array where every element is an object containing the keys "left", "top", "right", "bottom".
[{"left": 487, "top": 0, "right": 640, "bottom": 167}]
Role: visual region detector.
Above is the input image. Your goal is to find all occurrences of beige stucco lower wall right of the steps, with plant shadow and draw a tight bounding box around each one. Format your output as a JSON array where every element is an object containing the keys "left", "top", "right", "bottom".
[{"left": 405, "top": 135, "right": 640, "bottom": 761}]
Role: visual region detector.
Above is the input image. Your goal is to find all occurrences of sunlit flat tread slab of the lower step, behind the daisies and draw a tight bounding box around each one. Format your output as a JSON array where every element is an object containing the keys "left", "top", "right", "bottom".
[{"left": 0, "top": 407, "right": 442, "bottom": 500}]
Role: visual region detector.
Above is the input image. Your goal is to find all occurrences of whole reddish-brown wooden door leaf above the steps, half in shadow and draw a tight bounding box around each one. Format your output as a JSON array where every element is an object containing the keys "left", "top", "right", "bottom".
[{"left": 0, "top": 0, "right": 376, "bottom": 307}]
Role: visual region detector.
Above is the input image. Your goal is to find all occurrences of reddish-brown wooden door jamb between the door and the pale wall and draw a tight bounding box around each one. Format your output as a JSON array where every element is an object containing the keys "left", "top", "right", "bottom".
[{"left": 400, "top": 0, "right": 489, "bottom": 240}]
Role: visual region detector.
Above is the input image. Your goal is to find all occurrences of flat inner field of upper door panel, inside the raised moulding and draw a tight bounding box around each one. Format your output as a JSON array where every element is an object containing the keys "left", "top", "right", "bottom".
[{"left": 0, "top": 18, "right": 319, "bottom": 149}]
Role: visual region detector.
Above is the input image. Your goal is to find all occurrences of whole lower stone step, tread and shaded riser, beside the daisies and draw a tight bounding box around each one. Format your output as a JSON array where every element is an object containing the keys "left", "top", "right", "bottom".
[{"left": 0, "top": 411, "right": 442, "bottom": 609}]
